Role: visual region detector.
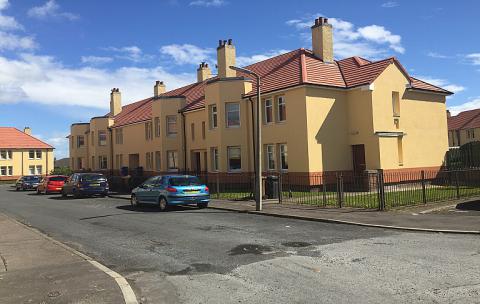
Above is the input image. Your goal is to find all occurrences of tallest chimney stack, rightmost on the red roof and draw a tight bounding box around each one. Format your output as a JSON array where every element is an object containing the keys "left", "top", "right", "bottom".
[{"left": 312, "top": 17, "right": 333, "bottom": 62}]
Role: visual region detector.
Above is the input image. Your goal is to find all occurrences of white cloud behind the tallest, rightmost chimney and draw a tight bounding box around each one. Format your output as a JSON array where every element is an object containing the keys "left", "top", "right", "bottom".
[{"left": 286, "top": 14, "right": 405, "bottom": 59}]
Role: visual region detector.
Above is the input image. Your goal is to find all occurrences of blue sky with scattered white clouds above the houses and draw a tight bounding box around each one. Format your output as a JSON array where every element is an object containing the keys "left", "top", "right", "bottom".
[{"left": 0, "top": 0, "right": 480, "bottom": 158}]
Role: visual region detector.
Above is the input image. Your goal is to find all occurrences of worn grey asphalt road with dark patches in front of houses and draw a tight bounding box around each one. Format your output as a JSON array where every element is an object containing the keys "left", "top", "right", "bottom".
[{"left": 0, "top": 185, "right": 480, "bottom": 303}]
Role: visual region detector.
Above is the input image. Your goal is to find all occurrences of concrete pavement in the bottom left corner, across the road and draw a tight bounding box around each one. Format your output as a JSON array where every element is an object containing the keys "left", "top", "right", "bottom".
[{"left": 0, "top": 214, "right": 131, "bottom": 304}]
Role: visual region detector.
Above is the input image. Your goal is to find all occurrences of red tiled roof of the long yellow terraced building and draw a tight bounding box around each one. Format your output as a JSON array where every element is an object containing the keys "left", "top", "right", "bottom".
[{"left": 107, "top": 49, "right": 451, "bottom": 127}]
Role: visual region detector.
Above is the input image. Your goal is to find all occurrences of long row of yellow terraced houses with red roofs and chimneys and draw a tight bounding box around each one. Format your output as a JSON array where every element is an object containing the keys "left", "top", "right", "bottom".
[{"left": 68, "top": 18, "right": 452, "bottom": 179}]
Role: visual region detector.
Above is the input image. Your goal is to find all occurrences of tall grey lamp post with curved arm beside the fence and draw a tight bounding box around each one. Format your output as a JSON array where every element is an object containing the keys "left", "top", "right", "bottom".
[{"left": 230, "top": 66, "right": 262, "bottom": 211}]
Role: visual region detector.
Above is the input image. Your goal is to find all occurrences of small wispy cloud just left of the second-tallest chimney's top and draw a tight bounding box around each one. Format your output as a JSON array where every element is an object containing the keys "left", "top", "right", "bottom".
[{"left": 160, "top": 44, "right": 215, "bottom": 64}]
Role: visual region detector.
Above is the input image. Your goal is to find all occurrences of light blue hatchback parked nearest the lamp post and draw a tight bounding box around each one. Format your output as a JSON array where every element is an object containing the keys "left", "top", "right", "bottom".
[{"left": 131, "top": 175, "right": 210, "bottom": 211}]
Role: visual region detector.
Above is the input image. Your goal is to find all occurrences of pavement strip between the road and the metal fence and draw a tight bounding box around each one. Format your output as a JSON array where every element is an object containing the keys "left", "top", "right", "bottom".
[{"left": 110, "top": 194, "right": 480, "bottom": 234}]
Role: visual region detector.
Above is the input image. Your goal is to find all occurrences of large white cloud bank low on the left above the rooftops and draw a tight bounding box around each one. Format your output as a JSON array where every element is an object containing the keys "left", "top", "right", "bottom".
[{"left": 0, "top": 54, "right": 195, "bottom": 109}]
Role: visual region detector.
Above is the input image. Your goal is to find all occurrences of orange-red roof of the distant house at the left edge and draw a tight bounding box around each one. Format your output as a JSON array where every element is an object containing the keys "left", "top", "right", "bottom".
[{"left": 0, "top": 127, "right": 53, "bottom": 149}]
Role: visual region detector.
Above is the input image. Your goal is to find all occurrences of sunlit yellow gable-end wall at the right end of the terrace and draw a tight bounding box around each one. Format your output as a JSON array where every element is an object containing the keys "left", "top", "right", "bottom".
[{"left": 372, "top": 64, "right": 448, "bottom": 169}]
